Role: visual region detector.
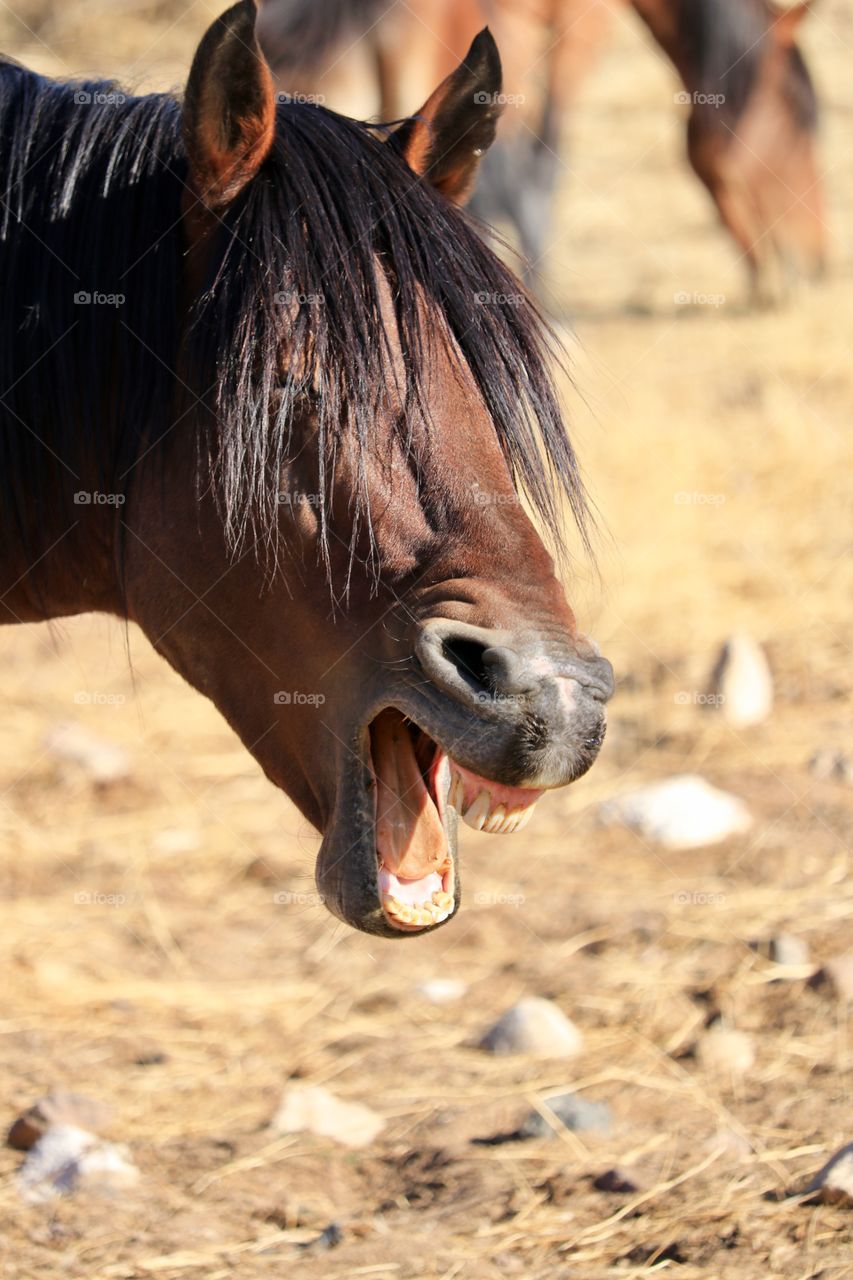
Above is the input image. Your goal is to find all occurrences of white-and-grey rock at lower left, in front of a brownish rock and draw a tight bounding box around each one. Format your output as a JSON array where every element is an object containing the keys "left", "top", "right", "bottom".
[{"left": 18, "top": 1124, "right": 140, "bottom": 1204}]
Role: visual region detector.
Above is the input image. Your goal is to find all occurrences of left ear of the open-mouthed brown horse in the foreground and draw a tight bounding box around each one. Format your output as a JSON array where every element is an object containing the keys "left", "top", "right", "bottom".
[{"left": 183, "top": 0, "right": 275, "bottom": 210}]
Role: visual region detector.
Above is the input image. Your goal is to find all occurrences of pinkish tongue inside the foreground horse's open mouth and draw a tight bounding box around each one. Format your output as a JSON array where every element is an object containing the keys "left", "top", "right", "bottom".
[{"left": 370, "top": 710, "right": 447, "bottom": 881}]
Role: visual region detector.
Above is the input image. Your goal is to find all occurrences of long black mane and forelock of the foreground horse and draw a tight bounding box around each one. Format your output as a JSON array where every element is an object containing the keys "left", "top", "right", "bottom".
[{"left": 0, "top": 63, "right": 585, "bottom": 586}]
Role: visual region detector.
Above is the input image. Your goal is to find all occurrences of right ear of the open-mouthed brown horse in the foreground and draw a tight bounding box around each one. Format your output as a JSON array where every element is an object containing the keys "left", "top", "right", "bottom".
[{"left": 393, "top": 27, "right": 503, "bottom": 205}]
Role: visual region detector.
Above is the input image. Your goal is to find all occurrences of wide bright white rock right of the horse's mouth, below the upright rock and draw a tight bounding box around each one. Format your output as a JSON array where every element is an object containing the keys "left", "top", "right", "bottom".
[{"left": 598, "top": 773, "right": 752, "bottom": 849}]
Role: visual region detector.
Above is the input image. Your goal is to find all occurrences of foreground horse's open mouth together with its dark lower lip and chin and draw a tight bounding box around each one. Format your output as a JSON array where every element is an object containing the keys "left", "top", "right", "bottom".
[{"left": 316, "top": 707, "right": 542, "bottom": 938}]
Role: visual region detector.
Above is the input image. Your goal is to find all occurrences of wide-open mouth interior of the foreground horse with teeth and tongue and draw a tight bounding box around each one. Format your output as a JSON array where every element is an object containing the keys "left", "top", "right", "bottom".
[{"left": 370, "top": 707, "right": 542, "bottom": 932}]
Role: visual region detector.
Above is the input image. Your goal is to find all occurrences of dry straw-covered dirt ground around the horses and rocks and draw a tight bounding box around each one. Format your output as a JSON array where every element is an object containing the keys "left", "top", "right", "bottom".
[{"left": 0, "top": 0, "right": 853, "bottom": 1280}]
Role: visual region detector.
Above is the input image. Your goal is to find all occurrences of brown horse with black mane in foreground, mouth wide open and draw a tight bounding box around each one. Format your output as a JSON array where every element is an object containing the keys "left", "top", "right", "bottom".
[{"left": 0, "top": 0, "right": 613, "bottom": 938}]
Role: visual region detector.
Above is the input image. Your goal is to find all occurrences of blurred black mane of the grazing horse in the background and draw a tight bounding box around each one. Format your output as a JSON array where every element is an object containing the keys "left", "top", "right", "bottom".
[{"left": 678, "top": 0, "right": 817, "bottom": 131}]
